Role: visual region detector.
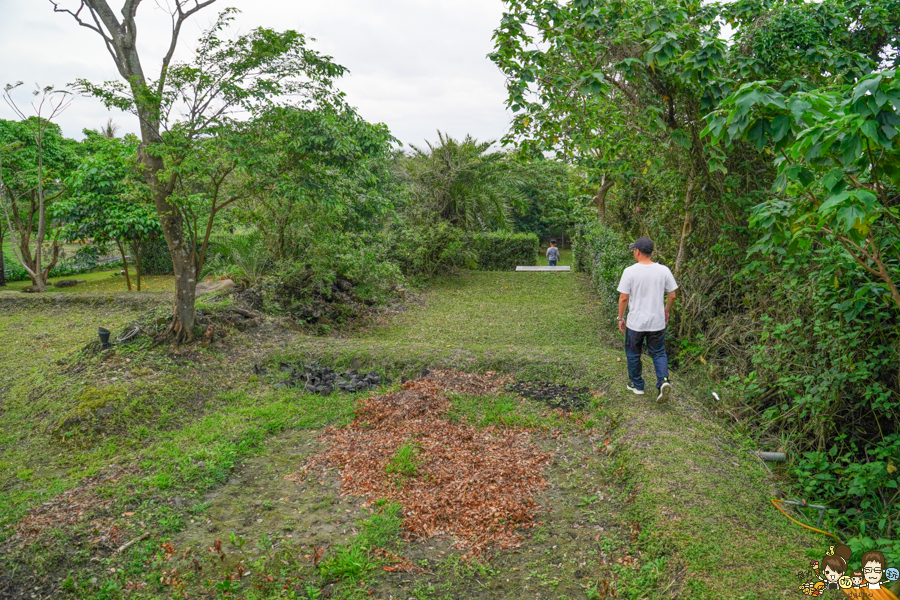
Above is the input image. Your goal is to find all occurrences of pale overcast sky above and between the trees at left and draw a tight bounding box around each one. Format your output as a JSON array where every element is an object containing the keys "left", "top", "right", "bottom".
[{"left": 0, "top": 0, "right": 509, "bottom": 145}]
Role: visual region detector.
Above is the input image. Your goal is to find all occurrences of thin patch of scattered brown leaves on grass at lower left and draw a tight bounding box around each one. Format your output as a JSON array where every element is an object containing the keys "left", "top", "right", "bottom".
[{"left": 15, "top": 465, "right": 139, "bottom": 547}]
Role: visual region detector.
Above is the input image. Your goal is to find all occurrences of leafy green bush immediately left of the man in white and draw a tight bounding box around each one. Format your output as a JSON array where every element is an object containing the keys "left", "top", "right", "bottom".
[{"left": 572, "top": 223, "right": 634, "bottom": 317}]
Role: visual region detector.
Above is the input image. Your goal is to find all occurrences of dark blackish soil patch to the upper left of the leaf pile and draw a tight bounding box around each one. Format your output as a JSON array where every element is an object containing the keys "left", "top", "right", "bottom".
[{"left": 253, "top": 362, "right": 391, "bottom": 395}]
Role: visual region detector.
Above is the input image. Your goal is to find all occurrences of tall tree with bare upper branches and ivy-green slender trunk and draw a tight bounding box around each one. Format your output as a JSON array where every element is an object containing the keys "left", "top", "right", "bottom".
[{"left": 50, "top": 0, "right": 344, "bottom": 342}]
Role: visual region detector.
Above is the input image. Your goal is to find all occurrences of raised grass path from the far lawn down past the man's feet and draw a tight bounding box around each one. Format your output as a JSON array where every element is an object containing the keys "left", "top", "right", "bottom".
[{"left": 294, "top": 264, "right": 829, "bottom": 599}]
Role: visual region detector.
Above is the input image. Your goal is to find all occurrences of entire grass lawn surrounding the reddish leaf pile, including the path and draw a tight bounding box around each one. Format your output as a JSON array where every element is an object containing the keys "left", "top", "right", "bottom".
[{"left": 0, "top": 268, "right": 827, "bottom": 600}]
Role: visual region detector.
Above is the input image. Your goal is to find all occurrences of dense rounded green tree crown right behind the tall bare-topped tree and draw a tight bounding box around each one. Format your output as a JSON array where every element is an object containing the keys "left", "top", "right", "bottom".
[{"left": 236, "top": 107, "right": 396, "bottom": 260}]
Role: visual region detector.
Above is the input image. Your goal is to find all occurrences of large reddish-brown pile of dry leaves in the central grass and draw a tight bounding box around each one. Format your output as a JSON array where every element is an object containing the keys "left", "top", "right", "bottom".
[{"left": 296, "top": 371, "right": 550, "bottom": 554}]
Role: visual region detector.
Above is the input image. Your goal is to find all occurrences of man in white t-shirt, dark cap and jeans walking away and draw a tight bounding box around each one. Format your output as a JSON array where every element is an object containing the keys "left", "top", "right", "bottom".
[{"left": 617, "top": 238, "right": 678, "bottom": 402}]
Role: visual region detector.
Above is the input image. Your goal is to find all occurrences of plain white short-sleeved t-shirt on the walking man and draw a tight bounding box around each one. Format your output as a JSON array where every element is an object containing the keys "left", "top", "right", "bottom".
[{"left": 616, "top": 263, "right": 678, "bottom": 331}]
